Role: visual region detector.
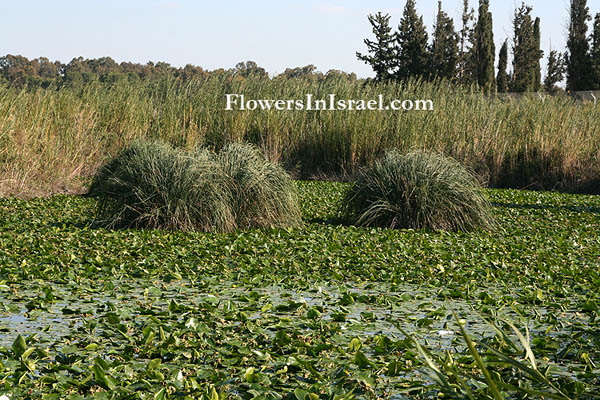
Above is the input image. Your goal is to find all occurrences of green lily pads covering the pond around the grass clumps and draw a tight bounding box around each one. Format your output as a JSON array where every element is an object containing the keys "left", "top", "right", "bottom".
[{"left": 0, "top": 182, "right": 600, "bottom": 400}]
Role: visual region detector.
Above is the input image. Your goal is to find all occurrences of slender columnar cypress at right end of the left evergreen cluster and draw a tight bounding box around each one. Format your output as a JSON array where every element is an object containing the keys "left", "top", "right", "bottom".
[{"left": 473, "top": 0, "right": 496, "bottom": 92}]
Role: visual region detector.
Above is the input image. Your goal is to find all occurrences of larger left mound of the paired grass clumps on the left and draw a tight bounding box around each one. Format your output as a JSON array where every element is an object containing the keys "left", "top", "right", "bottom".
[{"left": 89, "top": 142, "right": 234, "bottom": 232}]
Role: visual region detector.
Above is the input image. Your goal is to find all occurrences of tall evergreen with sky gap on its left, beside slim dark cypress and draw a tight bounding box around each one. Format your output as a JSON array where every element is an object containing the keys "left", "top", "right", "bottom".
[{"left": 511, "top": 3, "right": 539, "bottom": 92}]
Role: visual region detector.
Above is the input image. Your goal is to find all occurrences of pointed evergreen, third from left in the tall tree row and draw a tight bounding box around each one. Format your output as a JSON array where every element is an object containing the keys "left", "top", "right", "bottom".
[{"left": 430, "top": 1, "right": 458, "bottom": 80}]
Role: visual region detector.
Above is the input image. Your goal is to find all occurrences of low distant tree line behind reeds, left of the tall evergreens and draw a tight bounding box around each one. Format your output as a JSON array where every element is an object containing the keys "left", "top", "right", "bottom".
[{"left": 0, "top": 54, "right": 358, "bottom": 88}]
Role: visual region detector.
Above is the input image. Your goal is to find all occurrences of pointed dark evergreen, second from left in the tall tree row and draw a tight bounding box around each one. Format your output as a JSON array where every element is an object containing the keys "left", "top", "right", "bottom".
[{"left": 396, "top": 0, "right": 429, "bottom": 80}]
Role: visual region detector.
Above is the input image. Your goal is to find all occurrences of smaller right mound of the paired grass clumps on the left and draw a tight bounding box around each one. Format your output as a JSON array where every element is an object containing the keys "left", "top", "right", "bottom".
[{"left": 217, "top": 143, "right": 301, "bottom": 229}]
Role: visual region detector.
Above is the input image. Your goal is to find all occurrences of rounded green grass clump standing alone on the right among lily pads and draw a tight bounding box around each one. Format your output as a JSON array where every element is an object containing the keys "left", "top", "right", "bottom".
[{"left": 343, "top": 151, "right": 493, "bottom": 231}]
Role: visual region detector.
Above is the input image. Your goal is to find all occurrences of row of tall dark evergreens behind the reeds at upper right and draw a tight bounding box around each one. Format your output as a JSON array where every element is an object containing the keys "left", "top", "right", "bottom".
[{"left": 356, "top": 0, "right": 600, "bottom": 93}]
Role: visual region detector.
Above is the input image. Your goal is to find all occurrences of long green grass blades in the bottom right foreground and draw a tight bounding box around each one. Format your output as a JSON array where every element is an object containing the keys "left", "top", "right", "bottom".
[{"left": 392, "top": 312, "right": 571, "bottom": 400}]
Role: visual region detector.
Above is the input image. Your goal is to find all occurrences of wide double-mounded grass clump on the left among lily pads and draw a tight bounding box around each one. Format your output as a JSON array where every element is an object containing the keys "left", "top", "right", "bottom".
[{"left": 89, "top": 142, "right": 301, "bottom": 232}]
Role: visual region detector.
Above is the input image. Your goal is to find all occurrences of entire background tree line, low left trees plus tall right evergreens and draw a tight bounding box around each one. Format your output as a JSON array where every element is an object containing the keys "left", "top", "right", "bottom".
[{"left": 0, "top": 0, "right": 600, "bottom": 93}]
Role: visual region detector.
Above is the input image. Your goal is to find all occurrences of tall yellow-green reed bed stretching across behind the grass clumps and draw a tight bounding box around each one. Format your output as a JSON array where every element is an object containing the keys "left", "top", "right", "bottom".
[{"left": 0, "top": 73, "right": 600, "bottom": 195}]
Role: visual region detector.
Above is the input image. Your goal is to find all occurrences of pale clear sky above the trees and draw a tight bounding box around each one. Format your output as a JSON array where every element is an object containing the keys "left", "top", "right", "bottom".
[{"left": 0, "top": 0, "right": 600, "bottom": 77}]
